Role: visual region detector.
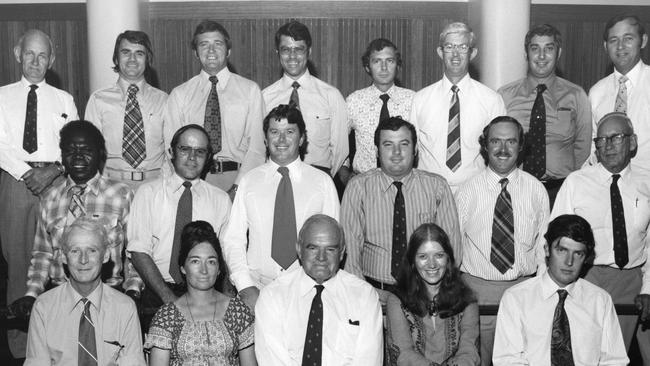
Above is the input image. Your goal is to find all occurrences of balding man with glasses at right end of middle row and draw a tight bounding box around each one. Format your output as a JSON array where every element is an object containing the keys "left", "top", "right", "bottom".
[{"left": 551, "top": 112, "right": 650, "bottom": 360}]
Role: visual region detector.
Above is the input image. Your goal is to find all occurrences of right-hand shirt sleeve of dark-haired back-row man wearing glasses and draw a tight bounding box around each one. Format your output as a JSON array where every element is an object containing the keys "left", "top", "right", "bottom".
[{"left": 328, "top": 90, "right": 350, "bottom": 177}]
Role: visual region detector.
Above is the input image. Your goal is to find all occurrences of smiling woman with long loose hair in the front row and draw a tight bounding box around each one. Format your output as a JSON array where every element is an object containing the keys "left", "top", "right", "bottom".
[{"left": 386, "top": 224, "right": 480, "bottom": 366}]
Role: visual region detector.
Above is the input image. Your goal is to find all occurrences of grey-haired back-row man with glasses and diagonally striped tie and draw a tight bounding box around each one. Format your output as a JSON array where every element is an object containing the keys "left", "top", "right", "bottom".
[{"left": 410, "top": 23, "right": 506, "bottom": 192}]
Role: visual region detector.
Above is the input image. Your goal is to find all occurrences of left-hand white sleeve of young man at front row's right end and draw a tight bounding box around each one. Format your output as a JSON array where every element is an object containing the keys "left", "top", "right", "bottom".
[{"left": 492, "top": 292, "right": 529, "bottom": 366}]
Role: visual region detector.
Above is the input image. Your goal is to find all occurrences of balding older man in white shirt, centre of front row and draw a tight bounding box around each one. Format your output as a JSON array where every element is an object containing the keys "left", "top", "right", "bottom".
[{"left": 255, "top": 214, "right": 383, "bottom": 366}]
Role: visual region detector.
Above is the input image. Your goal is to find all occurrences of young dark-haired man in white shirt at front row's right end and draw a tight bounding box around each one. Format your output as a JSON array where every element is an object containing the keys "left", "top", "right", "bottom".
[{"left": 493, "top": 215, "right": 629, "bottom": 366}]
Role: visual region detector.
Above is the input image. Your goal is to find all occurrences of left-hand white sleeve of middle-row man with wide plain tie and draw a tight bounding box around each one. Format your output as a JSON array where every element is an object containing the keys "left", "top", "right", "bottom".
[{"left": 222, "top": 179, "right": 255, "bottom": 291}]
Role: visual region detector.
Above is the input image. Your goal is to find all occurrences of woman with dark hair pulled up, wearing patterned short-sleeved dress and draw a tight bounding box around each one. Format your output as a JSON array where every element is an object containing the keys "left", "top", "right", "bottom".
[{"left": 145, "top": 221, "right": 257, "bottom": 366}]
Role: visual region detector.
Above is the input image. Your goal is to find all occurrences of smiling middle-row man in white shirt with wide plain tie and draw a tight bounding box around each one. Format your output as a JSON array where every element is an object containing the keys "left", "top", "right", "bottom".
[{"left": 222, "top": 104, "right": 339, "bottom": 307}]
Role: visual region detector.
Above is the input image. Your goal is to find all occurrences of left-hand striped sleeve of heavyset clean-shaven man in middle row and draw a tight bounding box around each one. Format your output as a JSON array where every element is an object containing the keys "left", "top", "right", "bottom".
[{"left": 341, "top": 177, "right": 365, "bottom": 279}]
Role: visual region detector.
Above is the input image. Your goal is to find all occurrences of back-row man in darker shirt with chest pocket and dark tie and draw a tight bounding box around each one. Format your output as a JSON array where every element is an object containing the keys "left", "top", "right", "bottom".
[{"left": 499, "top": 24, "right": 592, "bottom": 207}]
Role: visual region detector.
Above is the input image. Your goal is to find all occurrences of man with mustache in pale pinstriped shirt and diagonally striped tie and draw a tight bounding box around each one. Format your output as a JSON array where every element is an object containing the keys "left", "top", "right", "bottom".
[{"left": 456, "top": 116, "right": 549, "bottom": 365}]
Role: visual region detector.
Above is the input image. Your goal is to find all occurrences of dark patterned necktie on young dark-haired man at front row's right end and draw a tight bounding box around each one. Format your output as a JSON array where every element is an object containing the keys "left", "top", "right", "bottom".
[{"left": 551, "top": 290, "right": 574, "bottom": 366}]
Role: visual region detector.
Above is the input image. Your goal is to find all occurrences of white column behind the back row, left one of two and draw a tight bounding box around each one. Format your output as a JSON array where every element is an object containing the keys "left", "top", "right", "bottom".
[{"left": 86, "top": 0, "right": 141, "bottom": 93}]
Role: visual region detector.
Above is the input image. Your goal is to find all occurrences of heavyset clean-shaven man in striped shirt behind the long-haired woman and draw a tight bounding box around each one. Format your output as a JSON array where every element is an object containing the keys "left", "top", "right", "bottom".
[{"left": 341, "top": 117, "right": 461, "bottom": 305}]
